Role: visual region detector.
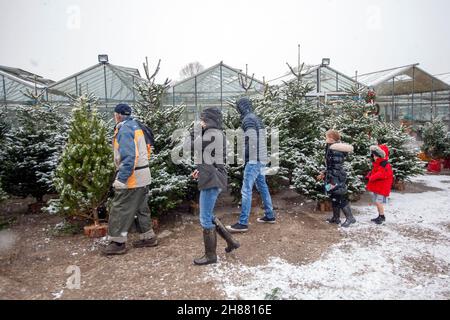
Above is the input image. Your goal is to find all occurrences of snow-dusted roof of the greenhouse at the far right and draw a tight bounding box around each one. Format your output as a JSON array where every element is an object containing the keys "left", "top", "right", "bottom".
[{"left": 358, "top": 64, "right": 450, "bottom": 96}]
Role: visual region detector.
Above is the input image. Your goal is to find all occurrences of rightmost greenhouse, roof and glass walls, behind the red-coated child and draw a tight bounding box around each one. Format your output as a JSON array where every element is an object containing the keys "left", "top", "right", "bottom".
[{"left": 358, "top": 64, "right": 450, "bottom": 124}]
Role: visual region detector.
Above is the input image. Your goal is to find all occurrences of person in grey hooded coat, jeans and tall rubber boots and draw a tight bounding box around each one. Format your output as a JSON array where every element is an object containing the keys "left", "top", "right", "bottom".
[{"left": 187, "top": 108, "right": 240, "bottom": 265}]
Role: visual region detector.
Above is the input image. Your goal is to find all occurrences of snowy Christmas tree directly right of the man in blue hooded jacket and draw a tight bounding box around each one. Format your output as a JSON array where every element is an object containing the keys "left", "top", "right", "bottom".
[{"left": 256, "top": 75, "right": 328, "bottom": 199}]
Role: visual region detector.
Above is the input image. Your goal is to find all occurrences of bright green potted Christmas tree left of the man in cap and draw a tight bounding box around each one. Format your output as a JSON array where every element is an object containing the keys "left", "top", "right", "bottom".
[{"left": 55, "top": 96, "right": 114, "bottom": 222}]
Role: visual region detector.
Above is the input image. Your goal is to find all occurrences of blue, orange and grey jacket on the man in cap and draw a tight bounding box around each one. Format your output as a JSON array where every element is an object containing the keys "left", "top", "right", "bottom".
[{"left": 113, "top": 119, "right": 151, "bottom": 189}]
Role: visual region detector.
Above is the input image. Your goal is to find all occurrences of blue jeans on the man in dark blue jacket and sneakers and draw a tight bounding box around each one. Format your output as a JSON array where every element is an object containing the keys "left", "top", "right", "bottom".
[{"left": 239, "top": 162, "right": 275, "bottom": 226}]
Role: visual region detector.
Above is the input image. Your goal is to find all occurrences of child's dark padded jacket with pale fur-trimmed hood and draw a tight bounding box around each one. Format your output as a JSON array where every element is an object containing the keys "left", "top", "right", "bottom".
[{"left": 325, "top": 142, "right": 353, "bottom": 195}]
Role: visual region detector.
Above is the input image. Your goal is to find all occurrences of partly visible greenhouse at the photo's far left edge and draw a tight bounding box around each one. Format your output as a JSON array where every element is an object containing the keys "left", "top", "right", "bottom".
[{"left": 0, "top": 66, "right": 54, "bottom": 106}]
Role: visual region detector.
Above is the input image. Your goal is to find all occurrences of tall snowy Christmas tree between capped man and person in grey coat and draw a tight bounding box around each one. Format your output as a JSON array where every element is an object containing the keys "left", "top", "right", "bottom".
[{"left": 134, "top": 60, "right": 196, "bottom": 217}]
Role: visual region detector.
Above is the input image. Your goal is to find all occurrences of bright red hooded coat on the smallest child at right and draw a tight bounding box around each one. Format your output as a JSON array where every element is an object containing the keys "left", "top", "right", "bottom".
[{"left": 366, "top": 145, "right": 394, "bottom": 197}]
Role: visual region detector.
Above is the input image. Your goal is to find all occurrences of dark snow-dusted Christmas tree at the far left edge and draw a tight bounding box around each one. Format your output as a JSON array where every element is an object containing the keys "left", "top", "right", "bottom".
[{"left": 0, "top": 100, "right": 67, "bottom": 202}]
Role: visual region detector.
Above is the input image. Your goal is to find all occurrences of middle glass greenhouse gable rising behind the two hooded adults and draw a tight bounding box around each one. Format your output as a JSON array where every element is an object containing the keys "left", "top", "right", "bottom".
[{"left": 164, "top": 62, "right": 264, "bottom": 120}]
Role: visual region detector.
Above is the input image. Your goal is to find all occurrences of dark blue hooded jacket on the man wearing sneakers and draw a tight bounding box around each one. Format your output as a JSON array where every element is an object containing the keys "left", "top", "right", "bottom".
[{"left": 236, "top": 98, "right": 267, "bottom": 163}]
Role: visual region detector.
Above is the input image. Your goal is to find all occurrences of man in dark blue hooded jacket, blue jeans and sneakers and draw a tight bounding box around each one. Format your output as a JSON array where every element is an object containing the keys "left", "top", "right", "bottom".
[{"left": 227, "top": 98, "right": 276, "bottom": 233}]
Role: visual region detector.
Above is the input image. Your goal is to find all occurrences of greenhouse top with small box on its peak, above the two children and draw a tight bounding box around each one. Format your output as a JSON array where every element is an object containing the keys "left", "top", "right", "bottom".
[{"left": 269, "top": 59, "right": 366, "bottom": 104}]
